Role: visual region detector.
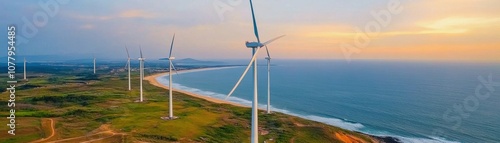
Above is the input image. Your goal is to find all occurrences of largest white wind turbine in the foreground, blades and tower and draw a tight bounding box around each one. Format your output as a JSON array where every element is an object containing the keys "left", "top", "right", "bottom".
[{"left": 226, "top": 0, "right": 283, "bottom": 143}]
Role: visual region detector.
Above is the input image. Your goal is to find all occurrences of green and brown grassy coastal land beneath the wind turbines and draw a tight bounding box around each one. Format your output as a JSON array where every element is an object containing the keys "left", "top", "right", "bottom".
[{"left": 0, "top": 67, "right": 378, "bottom": 143}]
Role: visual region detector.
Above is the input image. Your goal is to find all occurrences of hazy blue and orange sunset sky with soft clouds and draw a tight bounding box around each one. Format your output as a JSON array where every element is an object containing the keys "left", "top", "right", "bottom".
[{"left": 0, "top": 0, "right": 500, "bottom": 62}]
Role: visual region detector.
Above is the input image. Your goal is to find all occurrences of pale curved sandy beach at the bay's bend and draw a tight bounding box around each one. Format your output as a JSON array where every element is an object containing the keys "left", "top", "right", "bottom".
[{"left": 144, "top": 67, "right": 249, "bottom": 108}]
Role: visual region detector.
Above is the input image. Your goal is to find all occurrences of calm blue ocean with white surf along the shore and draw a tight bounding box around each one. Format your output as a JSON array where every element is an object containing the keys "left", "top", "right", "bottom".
[{"left": 158, "top": 60, "right": 500, "bottom": 143}]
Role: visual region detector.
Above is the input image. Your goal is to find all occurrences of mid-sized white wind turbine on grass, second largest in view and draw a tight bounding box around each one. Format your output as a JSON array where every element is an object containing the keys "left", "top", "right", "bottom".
[{"left": 162, "top": 34, "right": 177, "bottom": 120}]
